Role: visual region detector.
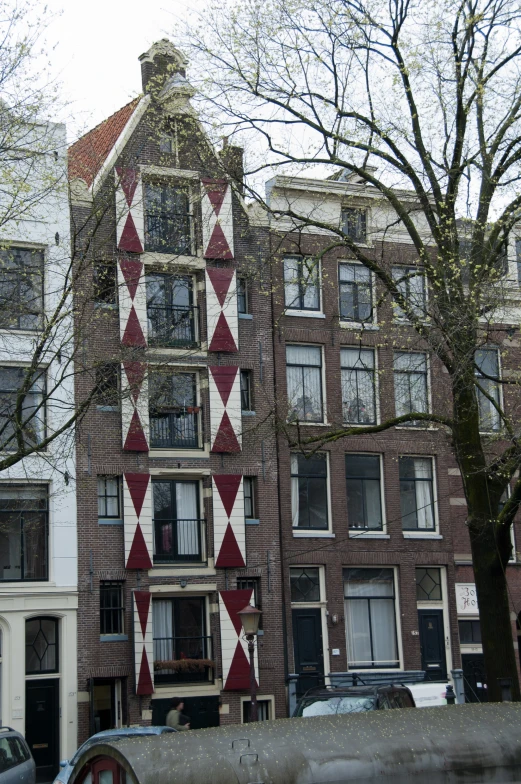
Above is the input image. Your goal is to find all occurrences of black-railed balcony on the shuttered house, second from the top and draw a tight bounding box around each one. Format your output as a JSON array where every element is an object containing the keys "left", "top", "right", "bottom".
[{"left": 147, "top": 305, "right": 199, "bottom": 348}]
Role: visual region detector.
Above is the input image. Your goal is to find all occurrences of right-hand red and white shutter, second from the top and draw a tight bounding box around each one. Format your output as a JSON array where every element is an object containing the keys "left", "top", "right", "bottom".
[{"left": 206, "top": 267, "right": 239, "bottom": 352}]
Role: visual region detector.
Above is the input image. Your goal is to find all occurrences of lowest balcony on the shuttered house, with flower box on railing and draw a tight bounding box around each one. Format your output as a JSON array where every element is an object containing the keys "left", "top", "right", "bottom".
[{"left": 154, "top": 637, "right": 215, "bottom": 684}]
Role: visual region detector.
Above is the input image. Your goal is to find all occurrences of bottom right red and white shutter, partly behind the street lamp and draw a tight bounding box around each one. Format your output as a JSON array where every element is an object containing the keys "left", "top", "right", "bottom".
[{"left": 219, "top": 589, "right": 259, "bottom": 691}]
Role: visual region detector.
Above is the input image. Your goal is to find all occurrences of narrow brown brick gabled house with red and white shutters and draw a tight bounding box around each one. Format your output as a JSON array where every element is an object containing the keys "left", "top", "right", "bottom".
[{"left": 70, "top": 41, "right": 286, "bottom": 742}]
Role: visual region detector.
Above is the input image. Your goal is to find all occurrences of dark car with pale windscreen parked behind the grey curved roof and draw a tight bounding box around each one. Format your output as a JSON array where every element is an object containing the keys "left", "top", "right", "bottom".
[{"left": 293, "top": 685, "right": 416, "bottom": 718}]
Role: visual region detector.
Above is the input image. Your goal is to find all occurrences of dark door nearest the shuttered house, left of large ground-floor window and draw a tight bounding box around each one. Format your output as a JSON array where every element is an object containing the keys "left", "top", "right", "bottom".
[{"left": 292, "top": 609, "right": 324, "bottom": 696}]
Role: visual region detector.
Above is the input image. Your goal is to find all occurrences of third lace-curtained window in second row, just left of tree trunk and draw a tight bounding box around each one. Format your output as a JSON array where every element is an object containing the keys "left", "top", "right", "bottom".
[{"left": 394, "top": 351, "right": 429, "bottom": 426}]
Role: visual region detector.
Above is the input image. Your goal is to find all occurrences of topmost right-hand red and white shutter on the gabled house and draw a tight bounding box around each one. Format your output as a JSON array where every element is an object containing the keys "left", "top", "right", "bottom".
[{"left": 201, "top": 179, "right": 234, "bottom": 260}]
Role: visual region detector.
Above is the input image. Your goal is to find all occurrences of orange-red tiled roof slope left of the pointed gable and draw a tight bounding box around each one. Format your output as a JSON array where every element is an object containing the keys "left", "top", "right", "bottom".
[{"left": 69, "top": 96, "right": 141, "bottom": 188}]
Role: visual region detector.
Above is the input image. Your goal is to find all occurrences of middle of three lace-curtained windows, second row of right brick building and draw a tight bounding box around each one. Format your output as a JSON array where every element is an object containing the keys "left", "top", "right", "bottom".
[{"left": 340, "top": 348, "right": 376, "bottom": 425}]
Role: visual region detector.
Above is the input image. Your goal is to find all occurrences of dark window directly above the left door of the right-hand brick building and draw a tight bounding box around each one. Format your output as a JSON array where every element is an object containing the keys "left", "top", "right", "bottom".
[{"left": 291, "top": 454, "right": 328, "bottom": 530}]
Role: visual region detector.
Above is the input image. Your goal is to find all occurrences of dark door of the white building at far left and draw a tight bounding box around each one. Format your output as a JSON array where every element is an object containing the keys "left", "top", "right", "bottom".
[{"left": 25, "top": 678, "right": 60, "bottom": 781}]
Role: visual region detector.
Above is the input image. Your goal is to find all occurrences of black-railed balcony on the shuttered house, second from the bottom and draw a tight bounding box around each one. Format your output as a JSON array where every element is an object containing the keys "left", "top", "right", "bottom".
[{"left": 154, "top": 518, "right": 207, "bottom": 564}]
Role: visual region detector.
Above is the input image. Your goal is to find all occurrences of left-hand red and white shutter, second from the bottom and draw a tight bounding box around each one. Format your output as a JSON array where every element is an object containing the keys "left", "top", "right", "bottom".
[{"left": 123, "top": 473, "right": 154, "bottom": 569}]
